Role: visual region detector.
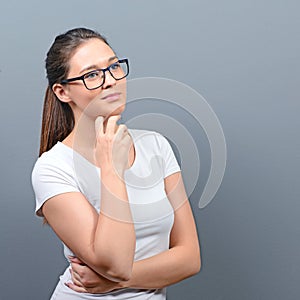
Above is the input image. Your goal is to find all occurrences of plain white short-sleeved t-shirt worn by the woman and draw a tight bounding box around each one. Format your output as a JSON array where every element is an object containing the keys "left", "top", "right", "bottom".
[{"left": 32, "top": 129, "right": 180, "bottom": 300}]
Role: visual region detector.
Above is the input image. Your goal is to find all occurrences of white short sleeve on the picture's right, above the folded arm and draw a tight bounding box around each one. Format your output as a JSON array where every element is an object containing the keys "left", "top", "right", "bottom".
[{"left": 159, "top": 134, "right": 180, "bottom": 178}]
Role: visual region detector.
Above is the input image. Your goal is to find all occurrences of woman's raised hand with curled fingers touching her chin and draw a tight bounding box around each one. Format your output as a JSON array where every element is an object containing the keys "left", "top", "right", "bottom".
[{"left": 95, "top": 115, "right": 132, "bottom": 176}]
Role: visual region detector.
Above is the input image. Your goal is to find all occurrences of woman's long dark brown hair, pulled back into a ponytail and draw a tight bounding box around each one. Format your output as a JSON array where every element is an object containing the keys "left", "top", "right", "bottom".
[{"left": 39, "top": 28, "right": 109, "bottom": 155}]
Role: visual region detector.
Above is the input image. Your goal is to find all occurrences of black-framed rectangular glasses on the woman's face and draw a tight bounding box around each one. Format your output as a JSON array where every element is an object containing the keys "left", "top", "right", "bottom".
[{"left": 60, "top": 58, "right": 129, "bottom": 90}]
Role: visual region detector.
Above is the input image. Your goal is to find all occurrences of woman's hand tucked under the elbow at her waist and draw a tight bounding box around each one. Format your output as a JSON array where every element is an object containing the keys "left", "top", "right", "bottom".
[{"left": 65, "top": 257, "right": 122, "bottom": 294}]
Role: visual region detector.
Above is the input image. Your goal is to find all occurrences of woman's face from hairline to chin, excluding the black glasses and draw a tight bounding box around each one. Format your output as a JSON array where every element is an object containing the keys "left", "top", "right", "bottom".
[{"left": 57, "top": 38, "right": 126, "bottom": 120}]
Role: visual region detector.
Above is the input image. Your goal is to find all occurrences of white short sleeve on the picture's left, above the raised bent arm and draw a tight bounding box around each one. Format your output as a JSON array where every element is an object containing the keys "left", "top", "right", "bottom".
[{"left": 31, "top": 159, "right": 79, "bottom": 217}]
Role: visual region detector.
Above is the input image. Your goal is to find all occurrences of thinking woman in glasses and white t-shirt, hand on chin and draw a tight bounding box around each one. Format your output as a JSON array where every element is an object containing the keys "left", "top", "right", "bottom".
[{"left": 32, "top": 28, "right": 200, "bottom": 300}]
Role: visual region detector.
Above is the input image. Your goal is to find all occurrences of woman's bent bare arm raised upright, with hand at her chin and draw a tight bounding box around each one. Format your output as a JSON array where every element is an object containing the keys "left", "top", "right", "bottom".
[{"left": 42, "top": 116, "right": 135, "bottom": 282}]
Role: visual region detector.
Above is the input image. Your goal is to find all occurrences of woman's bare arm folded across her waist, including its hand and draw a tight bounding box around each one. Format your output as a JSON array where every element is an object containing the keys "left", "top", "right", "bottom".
[{"left": 69, "top": 172, "right": 201, "bottom": 293}]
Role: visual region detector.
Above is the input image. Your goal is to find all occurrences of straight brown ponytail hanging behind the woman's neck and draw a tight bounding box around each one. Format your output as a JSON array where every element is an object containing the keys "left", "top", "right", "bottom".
[{"left": 39, "top": 86, "right": 75, "bottom": 156}]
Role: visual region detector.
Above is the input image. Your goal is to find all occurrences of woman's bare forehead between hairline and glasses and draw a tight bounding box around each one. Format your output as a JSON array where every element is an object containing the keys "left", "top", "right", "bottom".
[{"left": 69, "top": 38, "right": 115, "bottom": 74}]
